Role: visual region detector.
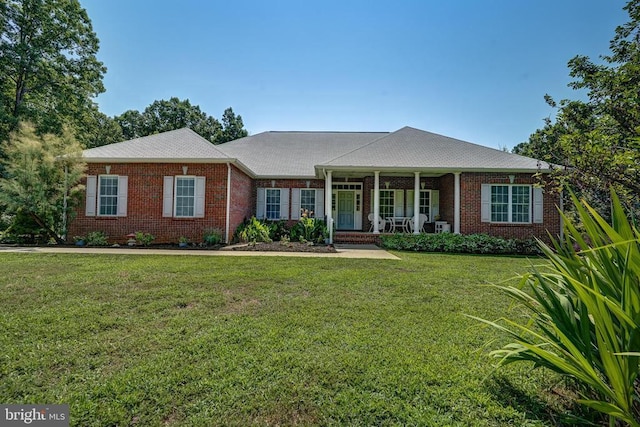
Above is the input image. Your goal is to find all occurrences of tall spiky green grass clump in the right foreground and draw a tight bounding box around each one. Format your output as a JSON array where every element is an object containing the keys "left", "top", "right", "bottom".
[{"left": 479, "top": 193, "right": 640, "bottom": 427}]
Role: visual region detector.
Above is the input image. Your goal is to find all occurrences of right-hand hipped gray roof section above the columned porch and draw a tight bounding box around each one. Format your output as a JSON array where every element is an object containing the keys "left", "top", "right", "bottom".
[{"left": 316, "top": 127, "right": 549, "bottom": 171}]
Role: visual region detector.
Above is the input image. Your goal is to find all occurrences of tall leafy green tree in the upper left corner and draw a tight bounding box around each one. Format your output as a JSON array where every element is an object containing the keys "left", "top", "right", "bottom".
[{"left": 0, "top": 0, "right": 106, "bottom": 141}]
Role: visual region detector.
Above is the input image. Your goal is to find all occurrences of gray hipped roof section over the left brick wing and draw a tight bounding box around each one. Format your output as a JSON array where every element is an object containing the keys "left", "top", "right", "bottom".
[{"left": 82, "top": 128, "right": 232, "bottom": 162}]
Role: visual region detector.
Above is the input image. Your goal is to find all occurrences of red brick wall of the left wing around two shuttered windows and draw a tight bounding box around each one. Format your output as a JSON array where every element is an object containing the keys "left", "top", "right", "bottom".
[{"left": 68, "top": 163, "right": 242, "bottom": 244}]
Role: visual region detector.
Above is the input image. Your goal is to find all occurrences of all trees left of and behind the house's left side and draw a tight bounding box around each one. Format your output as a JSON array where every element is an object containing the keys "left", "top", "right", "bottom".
[{"left": 0, "top": 0, "right": 248, "bottom": 242}]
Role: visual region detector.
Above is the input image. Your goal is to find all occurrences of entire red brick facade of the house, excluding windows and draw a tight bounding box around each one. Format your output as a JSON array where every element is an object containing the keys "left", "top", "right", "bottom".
[{"left": 68, "top": 163, "right": 560, "bottom": 244}]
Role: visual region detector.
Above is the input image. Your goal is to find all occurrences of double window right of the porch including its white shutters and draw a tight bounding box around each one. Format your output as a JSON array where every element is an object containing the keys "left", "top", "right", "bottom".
[{"left": 482, "top": 184, "right": 542, "bottom": 224}]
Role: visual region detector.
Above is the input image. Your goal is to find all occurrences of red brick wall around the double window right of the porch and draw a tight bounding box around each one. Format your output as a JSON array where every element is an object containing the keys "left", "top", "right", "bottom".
[{"left": 460, "top": 172, "right": 560, "bottom": 239}]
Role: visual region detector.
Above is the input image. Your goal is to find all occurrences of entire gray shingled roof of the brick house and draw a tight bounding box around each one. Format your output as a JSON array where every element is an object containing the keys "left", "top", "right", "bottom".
[{"left": 83, "top": 127, "right": 549, "bottom": 179}]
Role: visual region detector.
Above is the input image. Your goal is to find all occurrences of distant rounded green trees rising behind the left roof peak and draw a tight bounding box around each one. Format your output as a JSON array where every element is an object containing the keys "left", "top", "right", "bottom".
[{"left": 114, "top": 97, "right": 248, "bottom": 144}]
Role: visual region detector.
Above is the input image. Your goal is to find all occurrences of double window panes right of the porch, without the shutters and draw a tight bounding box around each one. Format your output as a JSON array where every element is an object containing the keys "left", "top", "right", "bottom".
[{"left": 491, "top": 185, "right": 531, "bottom": 223}]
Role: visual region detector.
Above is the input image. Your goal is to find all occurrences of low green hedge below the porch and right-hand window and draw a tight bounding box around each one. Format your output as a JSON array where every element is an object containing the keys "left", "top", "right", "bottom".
[{"left": 381, "top": 233, "right": 541, "bottom": 255}]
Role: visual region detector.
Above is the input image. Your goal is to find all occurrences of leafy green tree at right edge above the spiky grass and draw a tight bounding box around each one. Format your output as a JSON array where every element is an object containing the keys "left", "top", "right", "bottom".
[{"left": 514, "top": 0, "right": 640, "bottom": 215}]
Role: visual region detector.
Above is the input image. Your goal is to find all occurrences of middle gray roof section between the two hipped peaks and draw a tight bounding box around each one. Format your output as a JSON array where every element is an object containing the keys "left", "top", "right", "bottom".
[{"left": 218, "top": 132, "right": 388, "bottom": 178}]
